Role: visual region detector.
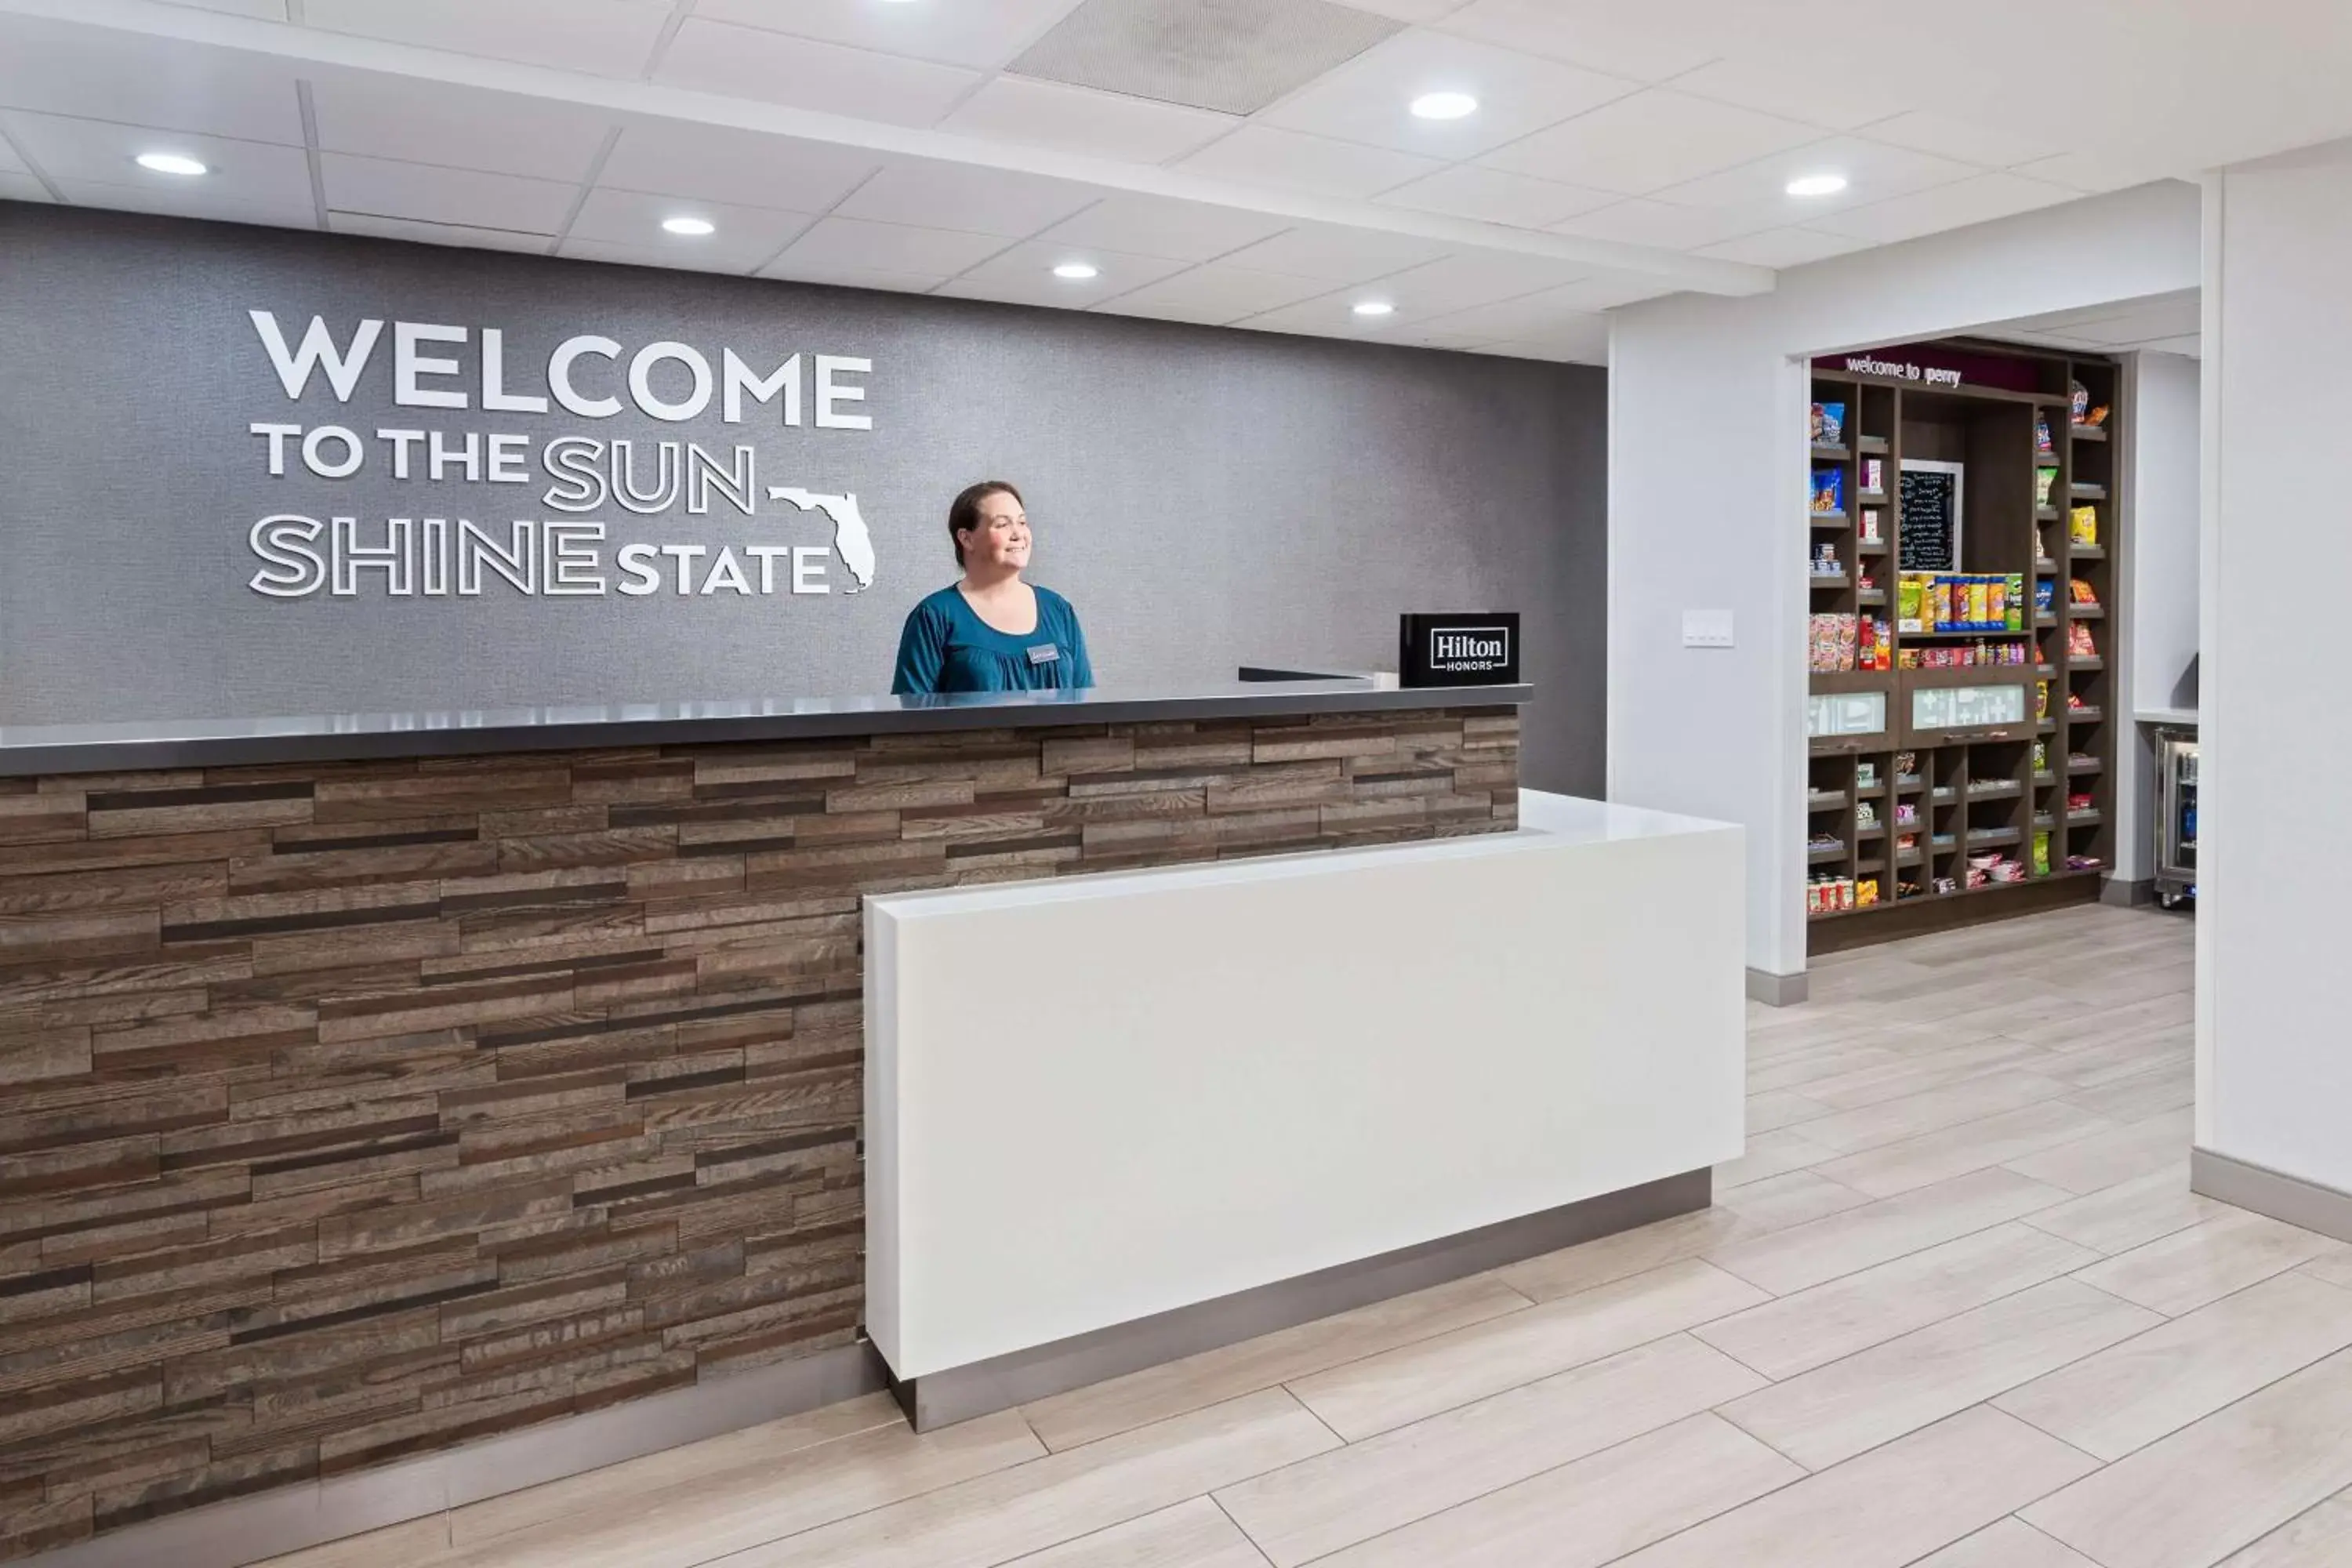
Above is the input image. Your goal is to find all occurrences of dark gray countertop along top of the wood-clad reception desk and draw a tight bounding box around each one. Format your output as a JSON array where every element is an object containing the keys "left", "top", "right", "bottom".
[{"left": 0, "top": 682, "right": 1534, "bottom": 779}]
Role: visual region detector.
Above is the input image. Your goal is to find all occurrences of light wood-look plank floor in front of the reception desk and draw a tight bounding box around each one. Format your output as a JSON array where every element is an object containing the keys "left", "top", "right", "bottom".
[{"left": 275, "top": 907, "right": 2352, "bottom": 1568}]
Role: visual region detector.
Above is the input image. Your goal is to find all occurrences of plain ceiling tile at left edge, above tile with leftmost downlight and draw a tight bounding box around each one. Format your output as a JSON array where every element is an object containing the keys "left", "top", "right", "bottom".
[{"left": 0, "top": 16, "right": 301, "bottom": 146}]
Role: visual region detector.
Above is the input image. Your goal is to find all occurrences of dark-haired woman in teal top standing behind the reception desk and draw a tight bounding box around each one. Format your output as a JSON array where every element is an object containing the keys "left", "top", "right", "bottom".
[{"left": 891, "top": 480, "right": 1094, "bottom": 696}]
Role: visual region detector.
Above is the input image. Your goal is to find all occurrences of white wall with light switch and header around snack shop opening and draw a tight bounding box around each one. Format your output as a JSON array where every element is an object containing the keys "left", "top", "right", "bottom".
[{"left": 1609, "top": 183, "right": 2199, "bottom": 975}]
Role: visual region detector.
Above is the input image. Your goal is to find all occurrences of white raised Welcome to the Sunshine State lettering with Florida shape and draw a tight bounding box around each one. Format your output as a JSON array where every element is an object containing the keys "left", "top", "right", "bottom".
[{"left": 247, "top": 310, "right": 875, "bottom": 600}]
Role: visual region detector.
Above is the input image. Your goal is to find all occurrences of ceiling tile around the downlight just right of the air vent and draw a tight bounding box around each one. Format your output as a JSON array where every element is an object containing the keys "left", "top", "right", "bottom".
[{"left": 1258, "top": 28, "right": 1639, "bottom": 160}]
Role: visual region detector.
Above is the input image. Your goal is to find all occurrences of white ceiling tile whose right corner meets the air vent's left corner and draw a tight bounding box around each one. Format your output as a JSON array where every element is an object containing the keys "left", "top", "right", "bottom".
[{"left": 654, "top": 16, "right": 981, "bottom": 127}]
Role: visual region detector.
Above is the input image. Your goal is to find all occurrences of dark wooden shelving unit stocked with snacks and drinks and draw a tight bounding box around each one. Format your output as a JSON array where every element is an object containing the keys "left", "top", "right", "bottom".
[{"left": 1804, "top": 341, "right": 2129, "bottom": 952}]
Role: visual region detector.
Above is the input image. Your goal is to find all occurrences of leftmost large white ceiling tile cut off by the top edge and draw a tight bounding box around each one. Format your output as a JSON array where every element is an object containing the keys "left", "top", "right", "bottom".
[{"left": 301, "top": 0, "right": 670, "bottom": 75}]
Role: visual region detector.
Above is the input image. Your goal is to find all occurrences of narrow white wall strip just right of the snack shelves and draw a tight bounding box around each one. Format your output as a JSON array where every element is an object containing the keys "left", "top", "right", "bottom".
[{"left": 2114, "top": 353, "right": 2201, "bottom": 881}]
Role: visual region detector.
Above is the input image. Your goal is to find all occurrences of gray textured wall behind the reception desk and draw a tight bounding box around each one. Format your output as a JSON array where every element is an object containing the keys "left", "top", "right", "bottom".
[{"left": 0, "top": 202, "right": 1606, "bottom": 794}]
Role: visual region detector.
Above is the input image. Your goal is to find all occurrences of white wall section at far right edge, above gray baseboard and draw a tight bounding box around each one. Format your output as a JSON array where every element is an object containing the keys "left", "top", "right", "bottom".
[{"left": 2197, "top": 143, "right": 2352, "bottom": 1192}]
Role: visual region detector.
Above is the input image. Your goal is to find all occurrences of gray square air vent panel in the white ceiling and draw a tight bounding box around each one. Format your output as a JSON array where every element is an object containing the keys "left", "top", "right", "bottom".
[{"left": 1009, "top": 0, "right": 1404, "bottom": 115}]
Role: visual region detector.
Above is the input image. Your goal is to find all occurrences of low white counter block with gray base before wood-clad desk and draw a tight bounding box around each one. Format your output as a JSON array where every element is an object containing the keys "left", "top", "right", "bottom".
[{"left": 866, "top": 792, "right": 1745, "bottom": 1425}]
